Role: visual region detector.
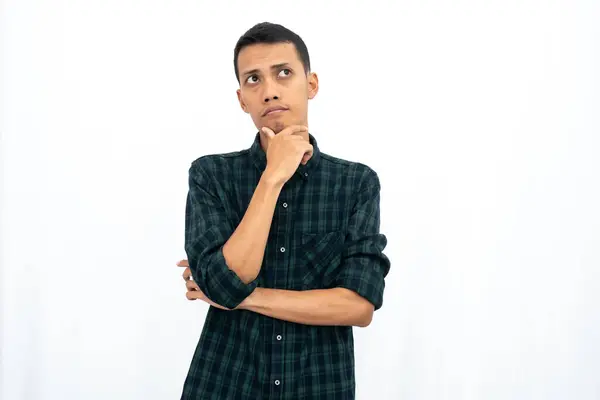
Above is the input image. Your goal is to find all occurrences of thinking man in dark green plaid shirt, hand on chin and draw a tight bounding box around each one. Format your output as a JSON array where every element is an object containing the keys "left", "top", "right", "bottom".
[{"left": 178, "top": 23, "right": 390, "bottom": 400}]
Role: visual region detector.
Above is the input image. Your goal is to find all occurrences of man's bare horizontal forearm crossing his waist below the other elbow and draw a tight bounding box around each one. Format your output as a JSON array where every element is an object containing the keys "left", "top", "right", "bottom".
[{"left": 238, "top": 287, "right": 373, "bottom": 327}]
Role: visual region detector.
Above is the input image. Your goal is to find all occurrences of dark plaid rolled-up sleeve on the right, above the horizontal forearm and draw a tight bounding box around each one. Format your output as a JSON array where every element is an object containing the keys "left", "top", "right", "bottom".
[{"left": 334, "top": 169, "right": 390, "bottom": 310}]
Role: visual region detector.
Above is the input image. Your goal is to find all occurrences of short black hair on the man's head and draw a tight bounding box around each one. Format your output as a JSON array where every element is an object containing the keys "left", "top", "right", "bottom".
[{"left": 233, "top": 22, "right": 310, "bottom": 83}]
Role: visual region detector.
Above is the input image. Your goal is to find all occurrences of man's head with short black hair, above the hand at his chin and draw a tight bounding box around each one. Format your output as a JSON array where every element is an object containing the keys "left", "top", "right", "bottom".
[{"left": 233, "top": 22, "right": 319, "bottom": 133}]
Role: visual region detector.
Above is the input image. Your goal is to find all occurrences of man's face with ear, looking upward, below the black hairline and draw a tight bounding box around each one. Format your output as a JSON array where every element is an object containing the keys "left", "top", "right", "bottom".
[{"left": 237, "top": 43, "right": 318, "bottom": 133}]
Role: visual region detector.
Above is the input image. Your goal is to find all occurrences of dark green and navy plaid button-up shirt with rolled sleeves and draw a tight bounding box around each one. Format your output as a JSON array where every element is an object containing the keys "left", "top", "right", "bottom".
[{"left": 181, "top": 133, "right": 390, "bottom": 400}]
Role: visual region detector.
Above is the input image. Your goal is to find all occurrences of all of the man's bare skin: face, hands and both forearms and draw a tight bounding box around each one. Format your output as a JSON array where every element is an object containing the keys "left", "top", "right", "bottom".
[{"left": 177, "top": 43, "right": 374, "bottom": 327}]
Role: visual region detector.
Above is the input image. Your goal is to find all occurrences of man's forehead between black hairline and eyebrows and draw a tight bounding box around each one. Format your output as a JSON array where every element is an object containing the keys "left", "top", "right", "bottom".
[{"left": 238, "top": 42, "right": 302, "bottom": 74}]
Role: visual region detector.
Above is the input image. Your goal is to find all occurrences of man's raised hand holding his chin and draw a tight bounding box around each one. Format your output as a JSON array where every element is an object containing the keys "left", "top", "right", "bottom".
[{"left": 262, "top": 125, "right": 313, "bottom": 184}]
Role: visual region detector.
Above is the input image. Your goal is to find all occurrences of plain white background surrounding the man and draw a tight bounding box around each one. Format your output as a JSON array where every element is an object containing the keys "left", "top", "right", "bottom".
[{"left": 0, "top": 0, "right": 600, "bottom": 400}]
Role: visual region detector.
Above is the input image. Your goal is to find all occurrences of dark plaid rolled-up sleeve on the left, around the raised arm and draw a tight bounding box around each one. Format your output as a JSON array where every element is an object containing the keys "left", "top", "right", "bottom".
[{"left": 185, "top": 159, "right": 257, "bottom": 309}]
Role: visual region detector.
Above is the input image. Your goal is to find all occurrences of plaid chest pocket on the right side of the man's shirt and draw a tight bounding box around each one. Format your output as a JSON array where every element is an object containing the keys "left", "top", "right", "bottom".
[{"left": 293, "top": 231, "right": 344, "bottom": 290}]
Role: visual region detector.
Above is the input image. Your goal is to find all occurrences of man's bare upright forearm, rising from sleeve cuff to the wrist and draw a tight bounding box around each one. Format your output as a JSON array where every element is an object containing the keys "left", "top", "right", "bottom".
[{"left": 223, "top": 175, "right": 283, "bottom": 283}]
